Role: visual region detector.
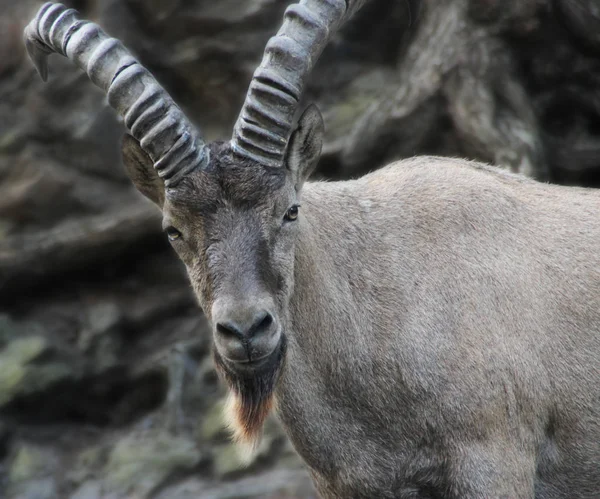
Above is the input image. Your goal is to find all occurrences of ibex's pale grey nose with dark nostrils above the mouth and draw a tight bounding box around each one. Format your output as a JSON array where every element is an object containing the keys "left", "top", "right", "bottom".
[{"left": 212, "top": 303, "right": 280, "bottom": 363}]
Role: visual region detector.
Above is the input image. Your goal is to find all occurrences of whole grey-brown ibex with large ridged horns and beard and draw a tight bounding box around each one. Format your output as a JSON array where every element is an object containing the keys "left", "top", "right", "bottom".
[{"left": 25, "top": 0, "right": 600, "bottom": 499}]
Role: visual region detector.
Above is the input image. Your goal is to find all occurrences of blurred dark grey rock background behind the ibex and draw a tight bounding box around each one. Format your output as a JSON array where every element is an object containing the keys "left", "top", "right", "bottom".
[{"left": 0, "top": 0, "right": 600, "bottom": 499}]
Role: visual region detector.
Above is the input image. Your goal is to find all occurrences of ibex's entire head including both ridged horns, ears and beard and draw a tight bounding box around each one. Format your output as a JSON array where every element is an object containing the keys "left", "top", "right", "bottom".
[{"left": 25, "top": 0, "right": 364, "bottom": 448}]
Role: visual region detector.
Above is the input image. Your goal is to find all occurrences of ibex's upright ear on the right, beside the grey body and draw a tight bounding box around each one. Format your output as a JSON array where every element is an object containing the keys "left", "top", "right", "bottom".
[{"left": 286, "top": 104, "right": 325, "bottom": 190}]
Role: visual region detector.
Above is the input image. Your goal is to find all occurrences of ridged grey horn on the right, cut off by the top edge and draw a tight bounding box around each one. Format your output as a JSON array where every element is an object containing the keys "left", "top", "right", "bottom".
[{"left": 231, "top": 0, "right": 366, "bottom": 166}]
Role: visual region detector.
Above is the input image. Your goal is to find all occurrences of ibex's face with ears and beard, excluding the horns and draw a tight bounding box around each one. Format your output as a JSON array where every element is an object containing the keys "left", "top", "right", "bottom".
[{"left": 123, "top": 106, "right": 323, "bottom": 446}]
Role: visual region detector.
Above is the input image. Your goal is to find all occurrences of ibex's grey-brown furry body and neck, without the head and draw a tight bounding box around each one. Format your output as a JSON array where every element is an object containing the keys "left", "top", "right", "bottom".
[{"left": 276, "top": 158, "right": 600, "bottom": 498}]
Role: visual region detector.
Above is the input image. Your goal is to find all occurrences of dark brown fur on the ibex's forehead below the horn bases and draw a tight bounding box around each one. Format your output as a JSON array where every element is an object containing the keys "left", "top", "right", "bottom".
[{"left": 167, "top": 143, "right": 286, "bottom": 212}]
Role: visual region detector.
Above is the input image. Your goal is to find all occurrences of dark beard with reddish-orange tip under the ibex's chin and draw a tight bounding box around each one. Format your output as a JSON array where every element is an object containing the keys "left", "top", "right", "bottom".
[{"left": 213, "top": 335, "right": 287, "bottom": 452}]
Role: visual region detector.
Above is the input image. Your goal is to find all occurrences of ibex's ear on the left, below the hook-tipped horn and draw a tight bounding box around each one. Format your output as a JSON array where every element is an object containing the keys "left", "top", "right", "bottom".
[{"left": 121, "top": 134, "right": 165, "bottom": 209}]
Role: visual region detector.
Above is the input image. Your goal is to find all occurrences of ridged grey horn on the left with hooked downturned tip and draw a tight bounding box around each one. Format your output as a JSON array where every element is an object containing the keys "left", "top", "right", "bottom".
[{"left": 24, "top": 3, "right": 209, "bottom": 187}]
